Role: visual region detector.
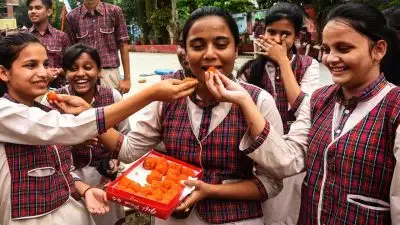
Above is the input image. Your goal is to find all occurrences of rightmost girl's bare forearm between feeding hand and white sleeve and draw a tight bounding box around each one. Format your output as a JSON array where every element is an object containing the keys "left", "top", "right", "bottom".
[{"left": 240, "top": 95, "right": 265, "bottom": 137}]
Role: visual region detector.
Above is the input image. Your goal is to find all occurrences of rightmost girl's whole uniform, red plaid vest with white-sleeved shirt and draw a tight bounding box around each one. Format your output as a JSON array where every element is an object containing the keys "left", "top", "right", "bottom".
[{"left": 248, "top": 75, "right": 400, "bottom": 225}]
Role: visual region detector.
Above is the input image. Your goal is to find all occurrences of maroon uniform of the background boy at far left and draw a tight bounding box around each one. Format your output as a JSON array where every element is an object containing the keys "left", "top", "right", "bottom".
[{"left": 28, "top": 24, "right": 70, "bottom": 88}]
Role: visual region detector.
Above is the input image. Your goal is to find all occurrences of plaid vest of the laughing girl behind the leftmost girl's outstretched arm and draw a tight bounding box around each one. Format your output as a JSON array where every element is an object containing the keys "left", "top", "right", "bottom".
[{"left": 56, "top": 85, "right": 114, "bottom": 169}]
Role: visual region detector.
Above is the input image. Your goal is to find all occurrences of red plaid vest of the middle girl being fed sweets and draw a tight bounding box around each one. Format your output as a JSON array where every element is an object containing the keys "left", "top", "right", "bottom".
[{"left": 161, "top": 72, "right": 263, "bottom": 224}]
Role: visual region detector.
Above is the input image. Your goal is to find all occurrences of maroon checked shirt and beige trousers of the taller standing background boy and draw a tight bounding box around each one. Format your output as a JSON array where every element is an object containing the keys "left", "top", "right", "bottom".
[{"left": 66, "top": 2, "right": 129, "bottom": 89}]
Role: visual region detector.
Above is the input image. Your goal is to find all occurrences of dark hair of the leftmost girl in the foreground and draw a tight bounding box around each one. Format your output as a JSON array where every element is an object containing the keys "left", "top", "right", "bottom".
[{"left": 0, "top": 32, "right": 41, "bottom": 97}]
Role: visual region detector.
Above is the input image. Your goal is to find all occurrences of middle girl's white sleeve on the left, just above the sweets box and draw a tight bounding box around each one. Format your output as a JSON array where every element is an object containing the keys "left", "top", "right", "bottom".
[{"left": 118, "top": 102, "right": 162, "bottom": 163}]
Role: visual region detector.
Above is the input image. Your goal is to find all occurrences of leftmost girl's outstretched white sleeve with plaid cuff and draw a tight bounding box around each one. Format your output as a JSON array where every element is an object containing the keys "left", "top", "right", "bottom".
[{"left": 0, "top": 98, "right": 106, "bottom": 145}]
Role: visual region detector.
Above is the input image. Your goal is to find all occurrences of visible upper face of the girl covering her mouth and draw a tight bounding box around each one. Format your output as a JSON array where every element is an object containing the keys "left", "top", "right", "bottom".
[{"left": 264, "top": 19, "right": 296, "bottom": 50}]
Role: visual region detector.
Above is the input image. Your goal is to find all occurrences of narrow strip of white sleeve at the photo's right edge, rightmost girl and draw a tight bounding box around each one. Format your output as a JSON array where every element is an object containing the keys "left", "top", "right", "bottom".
[{"left": 390, "top": 126, "right": 400, "bottom": 225}]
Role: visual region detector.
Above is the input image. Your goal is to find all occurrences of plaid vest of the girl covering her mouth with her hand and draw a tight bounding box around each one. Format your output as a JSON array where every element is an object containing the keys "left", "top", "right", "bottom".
[{"left": 241, "top": 55, "right": 312, "bottom": 134}]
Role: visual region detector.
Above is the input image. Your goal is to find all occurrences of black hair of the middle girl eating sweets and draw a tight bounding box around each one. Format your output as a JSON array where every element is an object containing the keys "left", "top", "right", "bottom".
[{"left": 182, "top": 6, "right": 239, "bottom": 50}]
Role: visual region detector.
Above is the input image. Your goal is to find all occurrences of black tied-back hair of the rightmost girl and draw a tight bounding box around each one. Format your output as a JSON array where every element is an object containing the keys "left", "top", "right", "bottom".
[{"left": 325, "top": 3, "right": 400, "bottom": 85}]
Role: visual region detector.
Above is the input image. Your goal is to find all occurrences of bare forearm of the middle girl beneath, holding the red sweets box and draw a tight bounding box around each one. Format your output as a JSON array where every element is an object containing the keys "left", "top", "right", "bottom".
[{"left": 207, "top": 180, "right": 261, "bottom": 200}]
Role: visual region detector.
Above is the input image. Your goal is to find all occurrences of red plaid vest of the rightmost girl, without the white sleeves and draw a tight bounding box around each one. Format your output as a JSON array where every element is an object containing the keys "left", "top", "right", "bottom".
[{"left": 298, "top": 78, "right": 400, "bottom": 225}]
